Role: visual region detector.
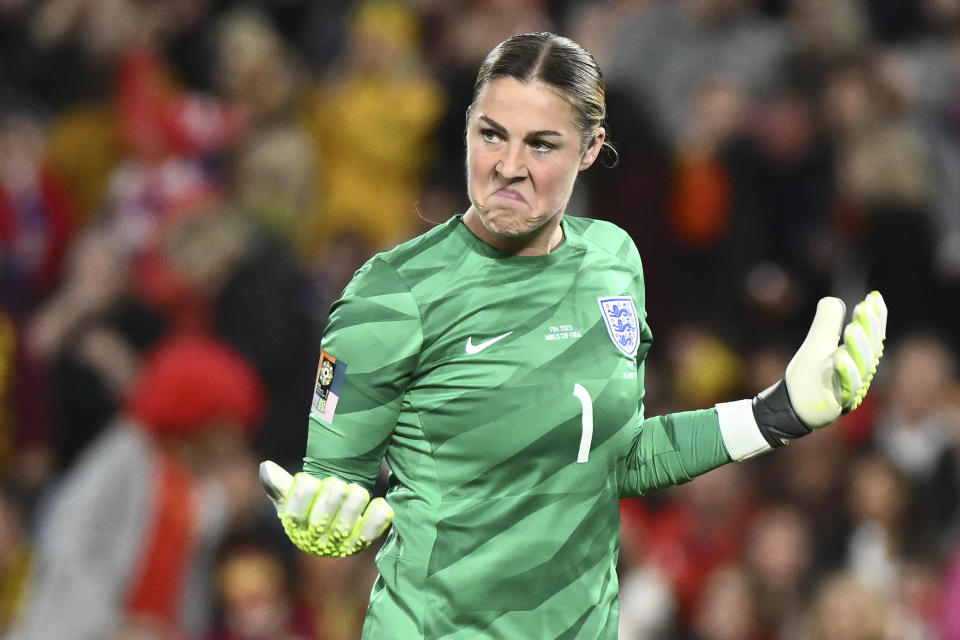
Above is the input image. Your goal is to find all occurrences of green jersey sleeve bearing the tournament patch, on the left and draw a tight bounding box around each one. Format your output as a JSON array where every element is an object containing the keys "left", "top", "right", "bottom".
[{"left": 304, "top": 257, "right": 423, "bottom": 487}]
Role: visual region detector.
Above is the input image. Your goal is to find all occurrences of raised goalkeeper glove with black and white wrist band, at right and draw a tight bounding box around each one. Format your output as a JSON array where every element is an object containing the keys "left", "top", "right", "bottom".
[{"left": 717, "top": 291, "right": 887, "bottom": 460}]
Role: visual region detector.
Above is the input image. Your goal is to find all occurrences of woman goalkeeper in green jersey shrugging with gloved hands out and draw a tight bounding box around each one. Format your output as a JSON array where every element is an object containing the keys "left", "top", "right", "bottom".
[{"left": 261, "top": 33, "right": 886, "bottom": 638}]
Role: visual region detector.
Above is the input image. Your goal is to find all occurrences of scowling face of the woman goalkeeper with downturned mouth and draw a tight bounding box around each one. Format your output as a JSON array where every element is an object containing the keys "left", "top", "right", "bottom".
[{"left": 467, "top": 77, "right": 604, "bottom": 250}]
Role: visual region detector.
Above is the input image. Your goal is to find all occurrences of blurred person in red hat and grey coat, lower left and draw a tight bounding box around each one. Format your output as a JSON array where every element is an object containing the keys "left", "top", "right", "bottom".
[{"left": 8, "top": 336, "right": 264, "bottom": 640}]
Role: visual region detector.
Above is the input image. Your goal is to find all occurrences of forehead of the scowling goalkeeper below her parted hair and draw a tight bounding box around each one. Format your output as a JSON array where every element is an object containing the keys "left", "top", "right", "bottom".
[{"left": 473, "top": 77, "right": 576, "bottom": 133}]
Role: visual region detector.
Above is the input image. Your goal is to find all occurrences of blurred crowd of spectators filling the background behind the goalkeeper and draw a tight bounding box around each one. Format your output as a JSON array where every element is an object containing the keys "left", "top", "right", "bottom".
[{"left": 0, "top": 0, "right": 960, "bottom": 640}]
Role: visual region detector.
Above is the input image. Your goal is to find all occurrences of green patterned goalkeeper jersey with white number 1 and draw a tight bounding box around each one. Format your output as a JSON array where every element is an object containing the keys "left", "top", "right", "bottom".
[{"left": 304, "top": 216, "right": 730, "bottom": 640}]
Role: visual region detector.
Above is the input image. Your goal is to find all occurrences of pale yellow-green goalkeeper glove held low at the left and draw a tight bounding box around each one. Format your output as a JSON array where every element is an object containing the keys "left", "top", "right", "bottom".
[{"left": 260, "top": 460, "right": 393, "bottom": 558}]
